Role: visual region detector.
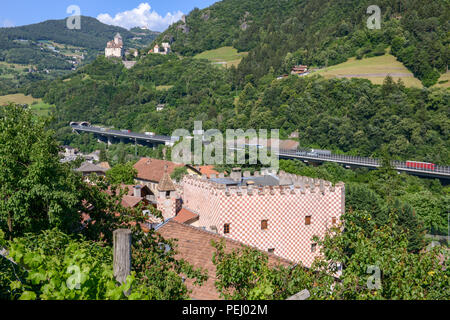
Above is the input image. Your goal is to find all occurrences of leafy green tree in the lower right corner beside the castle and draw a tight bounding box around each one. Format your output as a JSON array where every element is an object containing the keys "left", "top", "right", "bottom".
[{"left": 311, "top": 211, "right": 450, "bottom": 300}]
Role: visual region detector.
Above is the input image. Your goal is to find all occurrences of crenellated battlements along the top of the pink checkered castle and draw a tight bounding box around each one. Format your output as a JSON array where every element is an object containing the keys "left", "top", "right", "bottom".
[{"left": 183, "top": 170, "right": 345, "bottom": 197}]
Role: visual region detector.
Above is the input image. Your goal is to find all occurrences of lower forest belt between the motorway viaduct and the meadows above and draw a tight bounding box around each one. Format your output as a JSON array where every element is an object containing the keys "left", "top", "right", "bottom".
[{"left": 26, "top": 55, "right": 450, "bottom": 164}]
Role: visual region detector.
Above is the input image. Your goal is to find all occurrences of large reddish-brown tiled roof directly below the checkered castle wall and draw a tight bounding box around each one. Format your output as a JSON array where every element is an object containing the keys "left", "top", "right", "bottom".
[{"left": 157, "top": 220, "right": 294, "bottom": 300}]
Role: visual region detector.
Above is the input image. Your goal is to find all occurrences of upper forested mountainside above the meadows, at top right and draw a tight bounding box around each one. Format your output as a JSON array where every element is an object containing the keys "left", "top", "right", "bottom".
[{"left": 158, "top": 0, "right": 450, "bottom": 86}]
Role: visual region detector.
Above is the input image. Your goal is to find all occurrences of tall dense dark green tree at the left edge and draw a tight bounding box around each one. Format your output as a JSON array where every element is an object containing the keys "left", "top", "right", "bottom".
[{"left": 0, "top": 105, "right": 81, "bottom": 239}]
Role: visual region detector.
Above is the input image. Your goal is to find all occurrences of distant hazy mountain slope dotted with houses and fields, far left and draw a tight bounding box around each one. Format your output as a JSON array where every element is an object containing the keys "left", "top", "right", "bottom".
[{"left": 0, "top": 16, "right": 158, "bottom": 95}]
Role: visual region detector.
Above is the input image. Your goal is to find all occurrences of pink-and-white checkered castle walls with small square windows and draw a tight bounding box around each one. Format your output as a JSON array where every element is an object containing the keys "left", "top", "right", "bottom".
[{"left": 182, "top": 173, "right": 345, "bottom": 267}]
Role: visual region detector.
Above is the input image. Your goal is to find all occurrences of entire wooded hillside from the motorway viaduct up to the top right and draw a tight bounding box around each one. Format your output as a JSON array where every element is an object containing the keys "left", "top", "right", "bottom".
[{"left": 11, "top": 0, "right": 450, "bottom": 164}]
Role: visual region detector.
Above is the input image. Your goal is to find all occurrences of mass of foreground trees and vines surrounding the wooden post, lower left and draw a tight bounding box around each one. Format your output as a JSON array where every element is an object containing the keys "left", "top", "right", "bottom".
[{"left": 0, "top": 106, "right": 207, "bottom": 300}]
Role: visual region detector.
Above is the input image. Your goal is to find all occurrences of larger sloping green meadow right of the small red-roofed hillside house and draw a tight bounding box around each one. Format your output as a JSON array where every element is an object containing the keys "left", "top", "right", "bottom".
[{"left": 312, "top": 54, "right": 423, "bottom": 88}]
